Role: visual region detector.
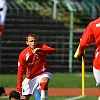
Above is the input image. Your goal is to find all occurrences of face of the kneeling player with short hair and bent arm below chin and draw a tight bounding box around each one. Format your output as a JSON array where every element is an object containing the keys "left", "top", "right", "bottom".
[{"left": 26, "top": 36, "right": 37, "bottom": 50}]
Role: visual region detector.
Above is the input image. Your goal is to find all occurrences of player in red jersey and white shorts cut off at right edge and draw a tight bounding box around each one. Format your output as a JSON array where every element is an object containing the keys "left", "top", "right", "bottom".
[{"left": 77, "top": 17, "right": 100, "bottom": 100}]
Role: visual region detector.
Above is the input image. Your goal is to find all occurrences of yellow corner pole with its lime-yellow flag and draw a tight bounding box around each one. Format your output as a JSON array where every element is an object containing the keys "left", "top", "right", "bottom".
[{"left": 74, "top": 46, "right": 85, "bottom": 95}]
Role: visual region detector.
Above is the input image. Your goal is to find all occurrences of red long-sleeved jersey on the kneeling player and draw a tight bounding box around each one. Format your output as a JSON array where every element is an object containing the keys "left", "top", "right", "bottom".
[{"left": 17, "top": 44, "right": 56, "bottom": 91}]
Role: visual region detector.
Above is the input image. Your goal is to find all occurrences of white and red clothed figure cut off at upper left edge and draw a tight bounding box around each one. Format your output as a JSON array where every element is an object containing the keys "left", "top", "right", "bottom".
[{"left": 0, "top": 0, "right": 7, "bottom": 36}]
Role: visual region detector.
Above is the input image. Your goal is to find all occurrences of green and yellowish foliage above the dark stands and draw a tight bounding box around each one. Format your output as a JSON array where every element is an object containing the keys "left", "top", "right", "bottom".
[{"left": 11, "top": 0, "right": 91, "bottom": 27}]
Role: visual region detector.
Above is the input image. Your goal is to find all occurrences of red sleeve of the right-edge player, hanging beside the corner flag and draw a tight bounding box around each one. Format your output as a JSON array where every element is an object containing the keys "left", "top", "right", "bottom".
[{"left": 78, "top": 23, "right": 94, "bottom": 55}]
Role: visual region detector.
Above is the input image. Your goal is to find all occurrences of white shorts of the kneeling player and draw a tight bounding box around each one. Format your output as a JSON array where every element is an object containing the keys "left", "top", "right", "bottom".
[{"left": 22, "top": 72, "right": 52, "bottom": 95}]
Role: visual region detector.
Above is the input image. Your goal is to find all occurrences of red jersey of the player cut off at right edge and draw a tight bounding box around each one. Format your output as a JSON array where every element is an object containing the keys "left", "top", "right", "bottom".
[{"left": 78, "top": 17, "right": 100, "bottom": 69}]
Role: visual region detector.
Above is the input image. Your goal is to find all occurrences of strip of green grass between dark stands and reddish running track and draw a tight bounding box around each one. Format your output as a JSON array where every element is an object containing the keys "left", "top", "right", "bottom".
[{"left": 0, "top": 73, "right": 96, "bottom": 88}]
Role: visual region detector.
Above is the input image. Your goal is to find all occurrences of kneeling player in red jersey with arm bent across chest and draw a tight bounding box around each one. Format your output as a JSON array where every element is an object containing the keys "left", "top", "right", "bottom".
[{"left": 17, "top": 34, "right": 56, "bottom": 100}]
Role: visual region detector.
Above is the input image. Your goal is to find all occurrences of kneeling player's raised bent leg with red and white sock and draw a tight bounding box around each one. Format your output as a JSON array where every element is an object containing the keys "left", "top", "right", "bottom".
[{"left": 40, "top": 72, "right": 52, "bottom": 100}]
